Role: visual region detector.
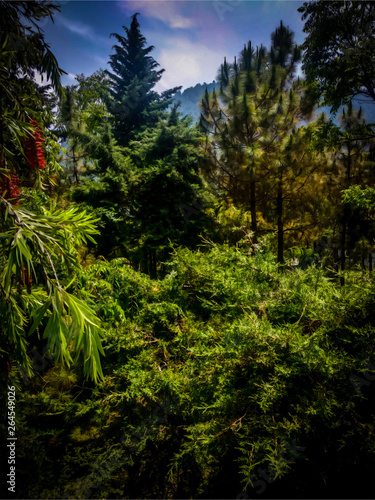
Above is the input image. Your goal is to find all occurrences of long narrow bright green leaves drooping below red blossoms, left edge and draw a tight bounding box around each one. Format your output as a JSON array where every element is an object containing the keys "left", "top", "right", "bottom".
[{"left": 0, "top": 195, "right": 104, "bottom": 380}]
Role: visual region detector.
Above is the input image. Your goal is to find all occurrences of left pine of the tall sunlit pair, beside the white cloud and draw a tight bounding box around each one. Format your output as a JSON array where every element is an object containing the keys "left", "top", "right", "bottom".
[{"left": 200, "top": 42, "right": 272, "bottom": 240}]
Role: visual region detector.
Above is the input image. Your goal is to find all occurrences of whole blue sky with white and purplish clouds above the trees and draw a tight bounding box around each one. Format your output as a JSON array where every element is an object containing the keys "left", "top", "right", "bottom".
[{"left": 41, "top": 0, "right": 304, "bottom": 92}]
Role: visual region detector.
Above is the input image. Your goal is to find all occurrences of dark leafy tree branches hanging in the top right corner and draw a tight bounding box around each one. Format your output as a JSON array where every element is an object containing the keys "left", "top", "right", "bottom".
[{"left": 298, "top": 0, "right": 375, "bottom": 111}]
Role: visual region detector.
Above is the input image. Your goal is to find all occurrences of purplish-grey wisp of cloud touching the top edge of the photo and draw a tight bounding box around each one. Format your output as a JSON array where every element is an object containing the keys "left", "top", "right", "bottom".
[{"left": 120, "top": 0, "right": 195, "bottom": 29}]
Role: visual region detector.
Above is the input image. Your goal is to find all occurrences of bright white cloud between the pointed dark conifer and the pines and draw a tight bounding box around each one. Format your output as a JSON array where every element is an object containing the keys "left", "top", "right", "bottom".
[{"left": 157, "top": 38, "right": 223, "bottom": 91}]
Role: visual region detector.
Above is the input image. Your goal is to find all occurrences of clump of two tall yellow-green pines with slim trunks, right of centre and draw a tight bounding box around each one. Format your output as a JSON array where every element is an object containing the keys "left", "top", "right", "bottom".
[{"left": 200, "top": 22, "right": 318, "bottom": 262}]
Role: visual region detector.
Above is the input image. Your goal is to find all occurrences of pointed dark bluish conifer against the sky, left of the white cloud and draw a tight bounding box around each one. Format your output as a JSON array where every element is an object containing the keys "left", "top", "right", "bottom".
[{"left": 107, "top": 13, "right": 181, "bottom": 146}]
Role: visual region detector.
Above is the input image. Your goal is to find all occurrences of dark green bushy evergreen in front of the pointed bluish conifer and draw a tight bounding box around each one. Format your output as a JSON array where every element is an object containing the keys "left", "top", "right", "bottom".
[{"left": 122, "top": 105, "right": 207, "bottom": 277}]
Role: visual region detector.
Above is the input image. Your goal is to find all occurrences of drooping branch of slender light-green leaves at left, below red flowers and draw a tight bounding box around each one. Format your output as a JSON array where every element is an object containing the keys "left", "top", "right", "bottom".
[{"left": 0, "top": 199, "right": 103, "bottom": 380}]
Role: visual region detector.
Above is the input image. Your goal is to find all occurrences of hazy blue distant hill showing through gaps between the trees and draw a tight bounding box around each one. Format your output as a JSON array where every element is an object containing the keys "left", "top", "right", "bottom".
[{"left": 174, "top": 80, "right": 375, "bottom": 124}]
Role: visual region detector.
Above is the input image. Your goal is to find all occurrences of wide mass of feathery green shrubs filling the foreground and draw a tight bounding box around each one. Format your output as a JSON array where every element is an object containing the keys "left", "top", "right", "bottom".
[{"left": 8, "top": 242, "right": 375, "bottom": 498}]
